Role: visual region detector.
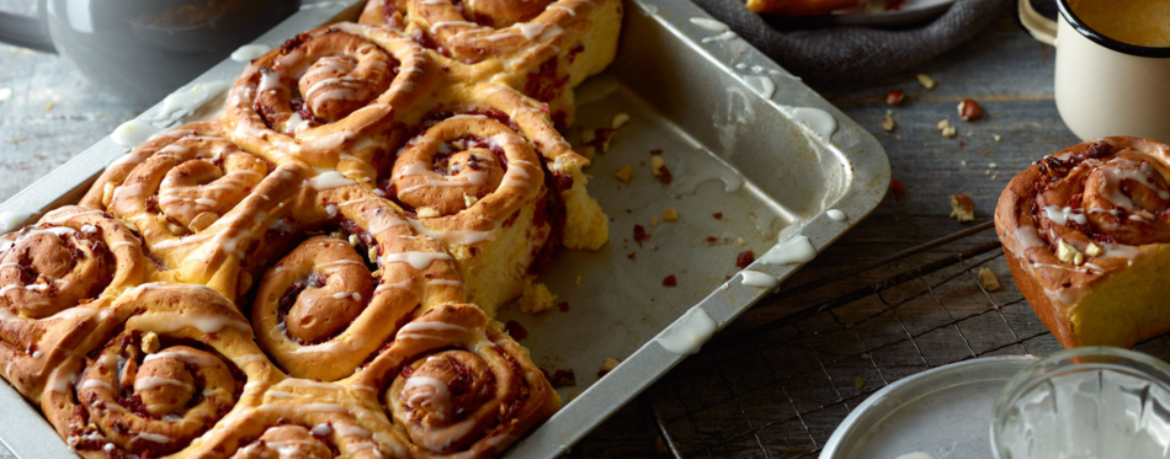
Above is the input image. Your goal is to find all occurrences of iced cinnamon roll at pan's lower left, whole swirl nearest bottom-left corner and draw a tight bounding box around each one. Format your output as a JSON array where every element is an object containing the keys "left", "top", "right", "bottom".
[{"left": 41, "top": 283, "right": 278, "bottom": 458}]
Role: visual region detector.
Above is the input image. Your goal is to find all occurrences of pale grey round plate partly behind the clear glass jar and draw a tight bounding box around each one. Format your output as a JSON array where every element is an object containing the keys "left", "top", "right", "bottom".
[{"left": 820, "top": 356, "right": 1038, "bottom": 459}]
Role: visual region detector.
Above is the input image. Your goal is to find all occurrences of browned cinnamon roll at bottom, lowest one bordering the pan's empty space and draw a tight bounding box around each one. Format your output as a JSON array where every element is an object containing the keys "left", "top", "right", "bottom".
[{"left": 353, "top": 304, "right": 560, "bottom": 457}]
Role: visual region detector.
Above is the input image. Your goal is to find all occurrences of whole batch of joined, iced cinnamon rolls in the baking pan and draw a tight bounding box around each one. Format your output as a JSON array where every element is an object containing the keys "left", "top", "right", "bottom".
[{"left": 0, "top": 8, "right": 621, "bottom": 458}]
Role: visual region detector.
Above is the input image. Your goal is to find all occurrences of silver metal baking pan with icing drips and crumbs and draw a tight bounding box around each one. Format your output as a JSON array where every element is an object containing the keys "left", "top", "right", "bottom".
[{"left": 0, "top": 0, "right": 889, "bottom": 458}]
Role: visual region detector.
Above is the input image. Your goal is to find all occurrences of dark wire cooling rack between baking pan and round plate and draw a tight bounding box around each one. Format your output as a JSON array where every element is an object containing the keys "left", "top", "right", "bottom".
[{"left": 647, "top": 222, "right": 1170, "bottom": 458}]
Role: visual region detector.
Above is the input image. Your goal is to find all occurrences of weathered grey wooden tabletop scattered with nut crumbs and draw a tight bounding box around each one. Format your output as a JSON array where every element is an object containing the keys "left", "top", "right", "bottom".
[{"left": 0, "top": 0, "right": 1079, "bottom": 458}]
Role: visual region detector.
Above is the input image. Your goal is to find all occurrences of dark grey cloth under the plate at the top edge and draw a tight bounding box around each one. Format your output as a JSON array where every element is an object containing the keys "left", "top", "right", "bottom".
[{"left": 693, "top": 0, "right": 1012, "bottom": 82}]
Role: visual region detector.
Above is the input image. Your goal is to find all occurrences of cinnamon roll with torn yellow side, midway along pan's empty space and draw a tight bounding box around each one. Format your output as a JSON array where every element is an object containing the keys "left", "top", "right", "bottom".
[{"left": 378, "top": 84, "right": 608, "bottom": 316}]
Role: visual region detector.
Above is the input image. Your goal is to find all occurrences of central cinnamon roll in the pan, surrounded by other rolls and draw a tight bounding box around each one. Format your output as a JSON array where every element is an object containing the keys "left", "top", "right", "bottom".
[{"left": 253, "top": 172, "right": 463, "bottom": 381}]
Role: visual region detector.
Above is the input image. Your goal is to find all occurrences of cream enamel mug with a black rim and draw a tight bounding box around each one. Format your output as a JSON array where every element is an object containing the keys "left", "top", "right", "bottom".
[{"left": 1018, "top": 0, "right": 1170, "bottom": 142}]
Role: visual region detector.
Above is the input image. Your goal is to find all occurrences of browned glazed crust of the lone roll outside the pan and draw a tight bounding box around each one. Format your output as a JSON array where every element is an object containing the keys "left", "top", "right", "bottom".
[{"left": 996, "top": 137, "right": 1170, "bottom": 348}]
